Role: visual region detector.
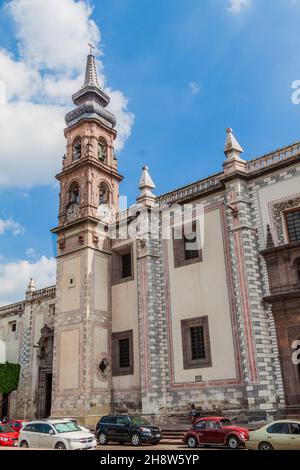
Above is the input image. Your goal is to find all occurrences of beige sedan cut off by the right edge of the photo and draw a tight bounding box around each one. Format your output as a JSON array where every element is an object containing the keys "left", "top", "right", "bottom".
[{"left": 246, "top": 419, "right": 300, "bottom": 450}]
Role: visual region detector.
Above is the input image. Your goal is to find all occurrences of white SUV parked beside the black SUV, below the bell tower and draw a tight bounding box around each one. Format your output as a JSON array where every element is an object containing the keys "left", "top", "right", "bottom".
[{"left": 18, "top": 419, "right": 97, "bottom": 450}]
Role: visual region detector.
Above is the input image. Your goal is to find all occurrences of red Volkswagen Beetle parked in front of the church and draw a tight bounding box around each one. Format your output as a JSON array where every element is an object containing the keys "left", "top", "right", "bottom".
[{"left": 183, "top": 417, "right": 249, "bottom": 449}]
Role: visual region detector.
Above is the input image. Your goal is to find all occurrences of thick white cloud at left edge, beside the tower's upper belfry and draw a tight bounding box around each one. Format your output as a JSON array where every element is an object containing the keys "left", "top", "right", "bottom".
[{"left": 0, "top": 101, "right": 65, "bottom": 187}]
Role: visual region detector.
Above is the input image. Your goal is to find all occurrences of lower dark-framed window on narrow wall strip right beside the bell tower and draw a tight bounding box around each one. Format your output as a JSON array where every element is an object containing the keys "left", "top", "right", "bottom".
[{"left": 112, "top": 330, "right": 134, "bottom": 376}]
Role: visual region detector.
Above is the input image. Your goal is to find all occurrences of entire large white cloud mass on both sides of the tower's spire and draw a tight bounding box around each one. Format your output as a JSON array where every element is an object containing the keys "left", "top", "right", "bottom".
[{"left": 0, "top": 0, "right": 134, "bottom": 187}]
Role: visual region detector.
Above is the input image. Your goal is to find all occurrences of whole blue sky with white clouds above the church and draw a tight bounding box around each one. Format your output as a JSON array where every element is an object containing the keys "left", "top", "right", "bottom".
[{"left": 0, "top": 0, "right": 300, "bottom": 305}]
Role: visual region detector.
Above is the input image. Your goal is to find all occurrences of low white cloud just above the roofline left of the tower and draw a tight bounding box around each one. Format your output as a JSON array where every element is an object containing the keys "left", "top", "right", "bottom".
[{"left": 0, "top": 256, "right": 56, "bottom": 305}]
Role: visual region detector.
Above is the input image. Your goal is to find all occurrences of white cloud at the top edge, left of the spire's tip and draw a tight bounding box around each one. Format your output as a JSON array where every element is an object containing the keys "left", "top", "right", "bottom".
[{"left": 7, "top": 0, "right": 100, "bottom": 72}]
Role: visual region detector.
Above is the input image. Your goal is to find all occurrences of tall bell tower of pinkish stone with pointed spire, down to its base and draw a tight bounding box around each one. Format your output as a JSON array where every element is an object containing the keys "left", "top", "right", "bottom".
[{"left": 51, "top": 51, "right": 122, "bottom": 424}]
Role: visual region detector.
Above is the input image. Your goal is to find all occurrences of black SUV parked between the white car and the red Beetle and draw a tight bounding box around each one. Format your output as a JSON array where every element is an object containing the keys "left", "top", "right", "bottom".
[{"left": 96, "top": 415, "right": 161, "bottom": 446}]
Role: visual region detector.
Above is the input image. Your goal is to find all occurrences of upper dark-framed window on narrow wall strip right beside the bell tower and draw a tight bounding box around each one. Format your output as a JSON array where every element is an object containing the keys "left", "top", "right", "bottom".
[{"left": 112, "top": 243, "right": 134, "bottom": 284}]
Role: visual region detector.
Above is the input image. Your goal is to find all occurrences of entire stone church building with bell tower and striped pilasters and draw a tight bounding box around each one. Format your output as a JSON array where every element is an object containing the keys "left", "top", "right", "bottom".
[{"left": 0, "top": 54, "right": 300, "bottom": 425}]
